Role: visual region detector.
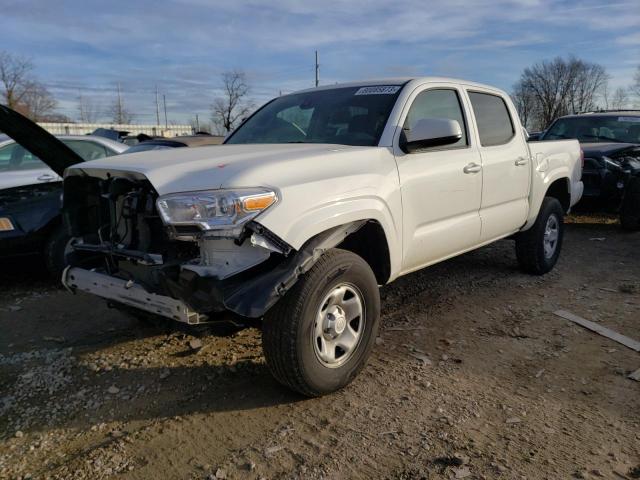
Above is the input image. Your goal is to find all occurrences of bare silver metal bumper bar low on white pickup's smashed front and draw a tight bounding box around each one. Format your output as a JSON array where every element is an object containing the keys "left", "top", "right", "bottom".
[{"left": 62, "top": 267, "right": 207, "bottom": 325}]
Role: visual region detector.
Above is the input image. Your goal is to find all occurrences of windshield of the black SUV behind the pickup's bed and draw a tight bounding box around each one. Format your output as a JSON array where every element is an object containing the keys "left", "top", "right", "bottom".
[{"left": 543, "top": 115, "right": 640, "bottom": 143}]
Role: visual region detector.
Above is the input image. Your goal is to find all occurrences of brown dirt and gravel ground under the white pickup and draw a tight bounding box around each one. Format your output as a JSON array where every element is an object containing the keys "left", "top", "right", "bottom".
[{"left": 0, "top": 218, "right": 640, "bottom": 480}]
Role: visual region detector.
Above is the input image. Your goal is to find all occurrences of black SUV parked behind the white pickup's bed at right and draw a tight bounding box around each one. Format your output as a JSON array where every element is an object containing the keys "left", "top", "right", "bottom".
[{"left": 540, "top": 110, "right": 640, "bottom": 230}]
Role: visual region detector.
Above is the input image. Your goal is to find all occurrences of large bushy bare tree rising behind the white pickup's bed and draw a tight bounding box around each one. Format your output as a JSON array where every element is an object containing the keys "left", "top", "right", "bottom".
[{"left": 514, "top": 57, "right": 608, "bottom": 129}]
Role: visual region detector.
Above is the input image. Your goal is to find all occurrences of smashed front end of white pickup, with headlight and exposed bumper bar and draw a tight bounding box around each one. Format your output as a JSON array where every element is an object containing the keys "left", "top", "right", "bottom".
[{"left": 63, "top": 169, "right": 359, "bottom": 324}]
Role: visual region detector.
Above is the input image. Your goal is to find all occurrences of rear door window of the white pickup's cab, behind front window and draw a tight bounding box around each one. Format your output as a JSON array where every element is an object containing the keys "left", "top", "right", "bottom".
[{"left": 469, "top": 92, "right": 515, "bottom": 147}]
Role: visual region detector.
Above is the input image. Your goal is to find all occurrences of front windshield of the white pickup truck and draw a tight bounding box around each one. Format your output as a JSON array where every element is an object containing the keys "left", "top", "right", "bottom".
[{"left": 225, "top": 85, "right": 402, "bottom": 146}]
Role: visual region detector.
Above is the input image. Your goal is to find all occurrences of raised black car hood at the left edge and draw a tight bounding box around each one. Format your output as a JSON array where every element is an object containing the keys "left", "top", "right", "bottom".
[{"left": 0, "top": 105, "right": 84, "bottom": 176}]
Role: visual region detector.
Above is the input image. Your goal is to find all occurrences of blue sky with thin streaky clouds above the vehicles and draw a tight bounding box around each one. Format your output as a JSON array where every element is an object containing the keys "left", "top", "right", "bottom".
[{"left": 0, "top": 0, "right": 640, "bottom": 123}]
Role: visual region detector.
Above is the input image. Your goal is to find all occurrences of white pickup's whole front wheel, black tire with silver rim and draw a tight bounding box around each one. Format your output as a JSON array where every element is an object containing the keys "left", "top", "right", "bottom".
[{"left": 262, "top": 249, "right": 380, "bottom": 397}]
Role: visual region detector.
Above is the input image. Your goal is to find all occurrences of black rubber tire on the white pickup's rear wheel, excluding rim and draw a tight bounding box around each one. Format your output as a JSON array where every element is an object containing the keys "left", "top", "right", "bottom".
[{"left": 516, "top": 197, "right": 564, "bottom": 275}]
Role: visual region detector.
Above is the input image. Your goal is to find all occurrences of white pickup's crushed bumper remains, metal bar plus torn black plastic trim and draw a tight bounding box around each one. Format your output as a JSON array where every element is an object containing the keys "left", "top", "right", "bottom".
[{"left": 62, "top": 221, "right": 366, "bottom": 324}]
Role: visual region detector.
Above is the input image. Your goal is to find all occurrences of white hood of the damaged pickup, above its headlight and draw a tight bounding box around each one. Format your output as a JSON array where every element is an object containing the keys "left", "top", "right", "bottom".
[{"left": 67, "top": 144, "right": 377, "bottom": 195}]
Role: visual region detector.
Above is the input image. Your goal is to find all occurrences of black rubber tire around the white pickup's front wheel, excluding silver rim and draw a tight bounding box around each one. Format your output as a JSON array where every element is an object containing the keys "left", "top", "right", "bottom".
[{"left": 262, "top": 249, "right": 380, "bottom": 397}]
